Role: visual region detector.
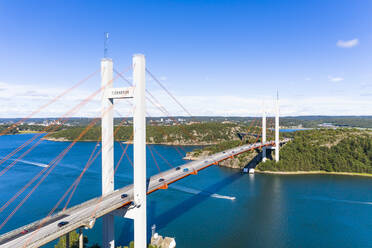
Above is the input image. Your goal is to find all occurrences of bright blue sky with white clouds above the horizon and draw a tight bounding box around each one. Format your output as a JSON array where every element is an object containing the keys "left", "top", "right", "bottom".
[{"left": 0, "top": 0, "right": 372, "bottom": 117}]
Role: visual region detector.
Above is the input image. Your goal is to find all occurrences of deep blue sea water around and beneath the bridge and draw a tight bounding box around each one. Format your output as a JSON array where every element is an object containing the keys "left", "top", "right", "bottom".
[{"left": 0, "top": 134, "right": 372, "bottom": 248}]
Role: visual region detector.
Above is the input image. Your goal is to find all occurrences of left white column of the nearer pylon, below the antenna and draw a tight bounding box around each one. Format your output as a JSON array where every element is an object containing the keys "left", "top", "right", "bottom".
[{"left": 101, "top": 58, "right": 115, "bottom": 248}]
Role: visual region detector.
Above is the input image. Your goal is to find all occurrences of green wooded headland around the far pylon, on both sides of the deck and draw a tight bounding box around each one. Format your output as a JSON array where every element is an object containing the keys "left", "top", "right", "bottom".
[{"left": 186, "top": 128, "right": 372, "bottom": 175}]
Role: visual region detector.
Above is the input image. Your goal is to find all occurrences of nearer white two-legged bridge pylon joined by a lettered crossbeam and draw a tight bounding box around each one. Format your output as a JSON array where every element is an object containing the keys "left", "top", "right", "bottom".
[{"left": 101, "top": 54, "right": 147, "bottom": 248}]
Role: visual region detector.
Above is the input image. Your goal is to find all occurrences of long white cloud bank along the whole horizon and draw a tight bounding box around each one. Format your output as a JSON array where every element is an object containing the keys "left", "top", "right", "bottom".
[{"left": 0, "top": 82, "right": 372, "bottom": 118}]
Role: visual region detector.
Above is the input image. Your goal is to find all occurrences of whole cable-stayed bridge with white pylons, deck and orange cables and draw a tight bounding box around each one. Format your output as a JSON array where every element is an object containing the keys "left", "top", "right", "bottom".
[{"left": 0, "top": 54, "right": 289, "bottom": 248}]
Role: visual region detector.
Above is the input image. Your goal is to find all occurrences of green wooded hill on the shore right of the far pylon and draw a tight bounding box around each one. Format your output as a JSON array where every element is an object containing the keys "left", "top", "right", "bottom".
[{"left": 256, "top": 128, "right": 372, "bottom": 174}]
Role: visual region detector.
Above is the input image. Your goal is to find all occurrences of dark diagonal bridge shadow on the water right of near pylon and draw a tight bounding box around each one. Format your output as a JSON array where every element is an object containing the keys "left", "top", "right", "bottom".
[{"left": 149, "top": 170, "right": 242, "bottom": 230}]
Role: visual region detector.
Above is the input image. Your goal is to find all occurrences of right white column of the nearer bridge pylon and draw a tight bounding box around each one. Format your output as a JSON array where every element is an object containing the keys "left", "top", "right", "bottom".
[{"left": 133, "top": 54, "right": 147, "bottom": 248}]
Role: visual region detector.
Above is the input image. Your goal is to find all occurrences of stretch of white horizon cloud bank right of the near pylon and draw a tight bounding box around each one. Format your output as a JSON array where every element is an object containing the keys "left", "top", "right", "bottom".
[{"left": 143, "top": 91, "right": 372, "bottom": 116}]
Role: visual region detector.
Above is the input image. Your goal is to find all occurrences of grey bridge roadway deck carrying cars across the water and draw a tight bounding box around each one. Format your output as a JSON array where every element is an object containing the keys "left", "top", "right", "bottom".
[{"left": 0, "top": 140, "right": 288, "bottom": 248}]
